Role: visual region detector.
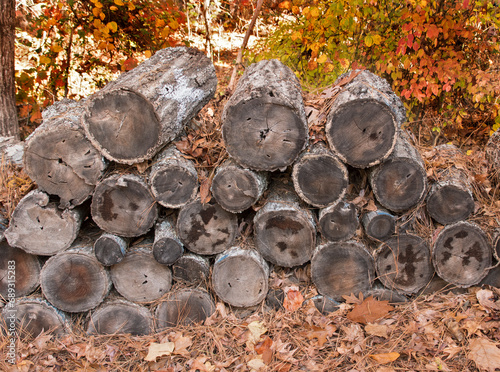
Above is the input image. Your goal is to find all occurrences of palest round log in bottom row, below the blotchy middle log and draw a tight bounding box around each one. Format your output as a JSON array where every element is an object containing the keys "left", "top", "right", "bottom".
[{"left": 212, "top": 247, "right": 269, "bottom": 307}]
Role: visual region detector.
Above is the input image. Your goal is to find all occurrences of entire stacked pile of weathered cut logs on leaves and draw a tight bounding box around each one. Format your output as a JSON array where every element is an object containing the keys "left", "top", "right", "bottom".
[{"left": 0, "top": 48, "right": 500, "bottom": 335}]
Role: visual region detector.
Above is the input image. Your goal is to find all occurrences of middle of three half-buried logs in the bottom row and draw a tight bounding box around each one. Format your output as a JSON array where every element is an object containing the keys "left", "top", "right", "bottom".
[{"left": 87, "top": 298, "right": 154, "bottom": 336}]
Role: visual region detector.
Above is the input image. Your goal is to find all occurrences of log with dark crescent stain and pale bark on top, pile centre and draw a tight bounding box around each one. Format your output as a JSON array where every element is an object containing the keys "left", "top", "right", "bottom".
[{"left": 254, "top": 184, "right": 316, "bottom": 267}]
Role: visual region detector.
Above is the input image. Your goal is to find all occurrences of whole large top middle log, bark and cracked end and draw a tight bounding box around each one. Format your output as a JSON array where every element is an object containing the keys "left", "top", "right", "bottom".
[{"left": 221, "top": 60, "right": 308, "bottom": 171}]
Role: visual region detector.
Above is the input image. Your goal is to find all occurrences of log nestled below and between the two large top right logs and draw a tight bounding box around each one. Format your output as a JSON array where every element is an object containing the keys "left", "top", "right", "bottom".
[{"left": 292, "top": 142, "right": 349, "bottom": 208}]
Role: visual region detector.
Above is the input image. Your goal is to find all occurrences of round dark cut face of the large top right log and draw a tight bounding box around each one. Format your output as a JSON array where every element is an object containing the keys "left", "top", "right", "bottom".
[{"left": 325, "top": 99, "right": 397, "bottom": 168}]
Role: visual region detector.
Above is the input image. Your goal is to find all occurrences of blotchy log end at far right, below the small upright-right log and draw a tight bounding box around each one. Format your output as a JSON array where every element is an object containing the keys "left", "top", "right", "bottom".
[{"left": 432, "top": 221, "right": 492, "bottom": 288}]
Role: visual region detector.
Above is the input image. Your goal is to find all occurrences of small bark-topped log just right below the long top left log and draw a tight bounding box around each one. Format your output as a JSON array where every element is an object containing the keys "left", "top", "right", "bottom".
[{"left": 148, "top": 145, "right": 198, "bottom": 208}]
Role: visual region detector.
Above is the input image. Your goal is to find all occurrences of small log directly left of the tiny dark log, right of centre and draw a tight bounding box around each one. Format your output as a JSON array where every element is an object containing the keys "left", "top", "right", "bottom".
[{"left": 318, "top": 200, "right": 359, "bottom": 241}]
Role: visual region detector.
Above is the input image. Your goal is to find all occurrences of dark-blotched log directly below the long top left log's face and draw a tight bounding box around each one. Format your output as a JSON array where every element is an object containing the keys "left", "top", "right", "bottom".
[{"left": 90, "top": 174, "right": 158, "bottom": 237}]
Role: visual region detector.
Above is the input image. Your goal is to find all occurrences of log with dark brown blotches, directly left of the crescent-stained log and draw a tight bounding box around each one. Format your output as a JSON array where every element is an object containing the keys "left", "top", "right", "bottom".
[{"left": 177, "top": 198, "right": 238, "bottom": 255}]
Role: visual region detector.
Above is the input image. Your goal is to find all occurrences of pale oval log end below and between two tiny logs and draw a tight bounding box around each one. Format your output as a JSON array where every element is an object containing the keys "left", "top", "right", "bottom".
[{"left": 110, "top": 247, "right": 172, "bottom": 303}]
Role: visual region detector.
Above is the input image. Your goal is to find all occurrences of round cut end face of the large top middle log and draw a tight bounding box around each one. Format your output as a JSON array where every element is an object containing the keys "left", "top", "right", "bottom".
[{"left": 222, "top": 98, "right": 307, "bottom": 171}]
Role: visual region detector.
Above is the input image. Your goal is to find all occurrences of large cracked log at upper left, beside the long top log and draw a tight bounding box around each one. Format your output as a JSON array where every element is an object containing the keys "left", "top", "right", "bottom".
[{"left": 24, "top": 99, "right": 107, "bottom": 208}]
